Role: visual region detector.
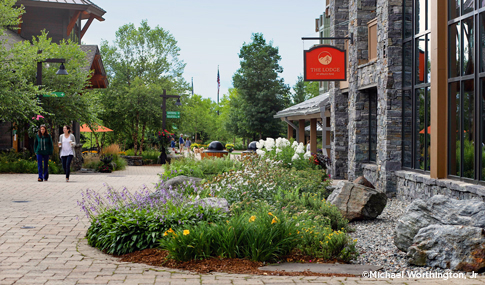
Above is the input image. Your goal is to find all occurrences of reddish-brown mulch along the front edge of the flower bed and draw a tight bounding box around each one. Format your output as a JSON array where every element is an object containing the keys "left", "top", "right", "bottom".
[{"left": 119, "top": 249, "right": 355, "bottom": 277}]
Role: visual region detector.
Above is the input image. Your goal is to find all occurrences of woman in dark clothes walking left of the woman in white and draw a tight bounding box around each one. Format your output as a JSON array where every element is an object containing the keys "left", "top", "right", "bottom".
[{"left": 34, "top": 125, "right": 54, "bottom": 182}]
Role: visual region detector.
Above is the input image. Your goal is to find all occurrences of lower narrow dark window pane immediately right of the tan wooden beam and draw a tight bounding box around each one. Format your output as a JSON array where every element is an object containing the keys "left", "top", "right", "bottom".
[{"left": 448, "top": 82, "right": 461, "bottom": 176}]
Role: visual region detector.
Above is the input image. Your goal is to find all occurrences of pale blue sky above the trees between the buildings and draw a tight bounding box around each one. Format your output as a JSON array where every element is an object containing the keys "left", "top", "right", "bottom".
[{"left": 82, "top": 0, "right": 325, "bottom": 101}]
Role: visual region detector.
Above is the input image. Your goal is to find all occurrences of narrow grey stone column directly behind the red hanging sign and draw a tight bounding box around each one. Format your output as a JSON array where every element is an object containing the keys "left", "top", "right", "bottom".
[{"left": 329, "top": 0, "right": 349, "bottom": 179}]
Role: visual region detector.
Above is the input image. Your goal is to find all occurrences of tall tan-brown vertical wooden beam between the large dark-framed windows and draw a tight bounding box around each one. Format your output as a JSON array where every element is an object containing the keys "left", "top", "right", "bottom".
[{"left": 429, "top": 0, "right": 448, "bottom": 178}]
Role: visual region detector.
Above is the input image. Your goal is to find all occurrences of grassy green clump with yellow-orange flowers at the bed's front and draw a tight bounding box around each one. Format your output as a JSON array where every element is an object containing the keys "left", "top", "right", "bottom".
[{"left": 160, "top": 204, "right": 297, "bottom": 261}]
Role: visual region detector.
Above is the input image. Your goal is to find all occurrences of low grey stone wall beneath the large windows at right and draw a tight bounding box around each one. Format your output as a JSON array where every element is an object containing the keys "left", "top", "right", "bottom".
[{"left": 396, "top": 170, "right": 485, "bottom": 202}]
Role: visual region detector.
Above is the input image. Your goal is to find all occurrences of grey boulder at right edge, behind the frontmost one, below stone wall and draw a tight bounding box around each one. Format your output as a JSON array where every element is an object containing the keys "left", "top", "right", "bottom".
[{"left": 394, "top": 195, "right": 485, "bottom": 251}]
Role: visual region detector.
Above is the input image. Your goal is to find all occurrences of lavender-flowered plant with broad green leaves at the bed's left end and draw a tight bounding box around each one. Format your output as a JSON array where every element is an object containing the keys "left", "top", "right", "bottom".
[{"left": 78, "top": 181, "right": 226, "bottom": 255}]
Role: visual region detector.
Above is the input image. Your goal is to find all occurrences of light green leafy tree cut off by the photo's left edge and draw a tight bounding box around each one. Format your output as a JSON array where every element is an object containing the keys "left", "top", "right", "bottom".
[{"left": 0, "top": 0, "right": 42, "bottom": 122}]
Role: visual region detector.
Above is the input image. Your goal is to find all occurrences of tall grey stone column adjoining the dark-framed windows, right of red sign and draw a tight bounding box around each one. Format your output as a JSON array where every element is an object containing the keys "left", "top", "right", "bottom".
[{"left": 376, "top": 0, "right": 404, "bottom": 196}]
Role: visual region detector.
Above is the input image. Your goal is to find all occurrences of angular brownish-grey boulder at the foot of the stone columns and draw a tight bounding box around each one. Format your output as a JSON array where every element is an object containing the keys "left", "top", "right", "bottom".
[{"left": 327, "top": 181, "right": 387, "bottom": 221}]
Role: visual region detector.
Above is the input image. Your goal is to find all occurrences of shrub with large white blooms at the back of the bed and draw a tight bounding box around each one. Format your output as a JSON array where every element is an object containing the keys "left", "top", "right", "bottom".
[{"left": 256, "top": 138, "right": 314, "bottom": 170}]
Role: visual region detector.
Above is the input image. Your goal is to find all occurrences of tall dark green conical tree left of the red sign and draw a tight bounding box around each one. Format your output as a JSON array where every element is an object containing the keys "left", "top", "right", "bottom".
[{"left": 233, "top": 33, "right": 289, "bottom": 138}]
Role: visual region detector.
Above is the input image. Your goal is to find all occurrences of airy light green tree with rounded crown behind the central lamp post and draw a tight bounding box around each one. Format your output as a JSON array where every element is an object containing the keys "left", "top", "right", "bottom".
[{"left": 100, "top": 20, "right": 188, "bottom": 155}]
